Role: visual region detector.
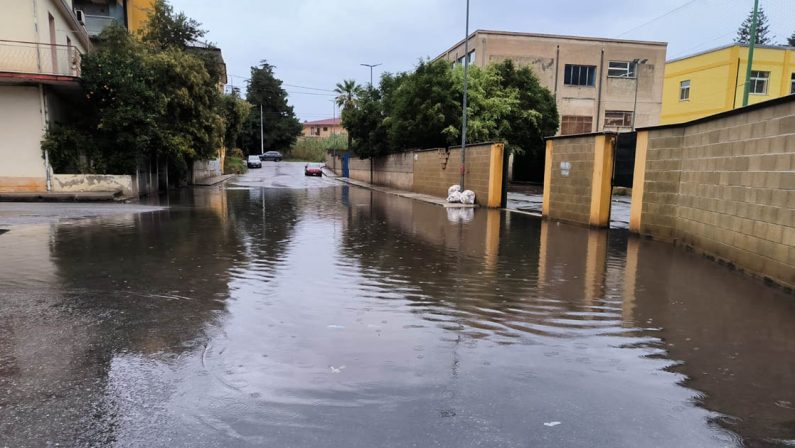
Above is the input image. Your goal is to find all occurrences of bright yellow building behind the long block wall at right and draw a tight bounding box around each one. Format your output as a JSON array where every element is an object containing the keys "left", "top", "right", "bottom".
[{"left": 660, "top": 44, "right": 795, "bottom": 124}]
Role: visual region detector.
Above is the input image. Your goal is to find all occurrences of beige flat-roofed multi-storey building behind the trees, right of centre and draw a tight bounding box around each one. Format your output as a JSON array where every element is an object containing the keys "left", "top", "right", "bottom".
[{"left": 436, "top": 30, "right": 667, "bottom": 134}]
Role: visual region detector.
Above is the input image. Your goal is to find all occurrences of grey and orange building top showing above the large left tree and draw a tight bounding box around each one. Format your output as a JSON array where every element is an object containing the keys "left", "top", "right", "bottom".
[{"left": 68, "top": 0, "right": 155, "bottom": 38}]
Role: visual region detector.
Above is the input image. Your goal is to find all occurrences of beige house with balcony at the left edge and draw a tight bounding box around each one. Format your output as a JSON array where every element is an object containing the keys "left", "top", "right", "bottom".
[{"left": 0, "top": 0, "right": 91, "bottom": 192}]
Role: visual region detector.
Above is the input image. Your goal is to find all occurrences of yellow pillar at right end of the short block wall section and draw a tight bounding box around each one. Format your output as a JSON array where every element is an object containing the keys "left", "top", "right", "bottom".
[{"left": 588, "top": 135, "right": 616, "bottom": 227}]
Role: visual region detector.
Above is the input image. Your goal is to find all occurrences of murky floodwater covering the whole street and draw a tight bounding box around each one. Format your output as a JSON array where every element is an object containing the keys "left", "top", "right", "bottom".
[{"left": 0, "top": 163, "right": 795, "bottom": 447}]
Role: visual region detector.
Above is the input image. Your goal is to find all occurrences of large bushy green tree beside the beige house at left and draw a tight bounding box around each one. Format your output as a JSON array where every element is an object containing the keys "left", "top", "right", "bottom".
[{"left": 43, "top": 2, "right": 224, "bottom": 178}]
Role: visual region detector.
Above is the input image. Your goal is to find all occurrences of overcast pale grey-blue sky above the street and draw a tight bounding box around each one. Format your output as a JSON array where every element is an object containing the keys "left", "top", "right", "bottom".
[{"left": 171, "top": 0, "right": 795, "bottom": 121}]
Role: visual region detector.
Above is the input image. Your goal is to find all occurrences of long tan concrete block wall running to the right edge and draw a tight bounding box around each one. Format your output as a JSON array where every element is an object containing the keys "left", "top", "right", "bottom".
[{"left": 630, "top": 97, "right": 795, "bottom": 287}]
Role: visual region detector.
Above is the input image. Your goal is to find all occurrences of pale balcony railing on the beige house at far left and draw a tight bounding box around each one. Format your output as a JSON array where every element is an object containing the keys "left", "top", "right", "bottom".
[{"left": 0, "top": 40, "right": 81, "bottom": 77}]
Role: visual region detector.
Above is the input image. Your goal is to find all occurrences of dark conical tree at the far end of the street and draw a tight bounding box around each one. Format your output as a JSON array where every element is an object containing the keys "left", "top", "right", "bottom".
[{"left": 243, "top": 61, "right": 303, "bottom": 154}]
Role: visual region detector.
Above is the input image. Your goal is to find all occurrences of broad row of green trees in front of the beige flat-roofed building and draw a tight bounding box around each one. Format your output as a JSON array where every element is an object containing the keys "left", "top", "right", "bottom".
[{"left": 342, "top": 61, "right": 559, "bottom": 163}]
